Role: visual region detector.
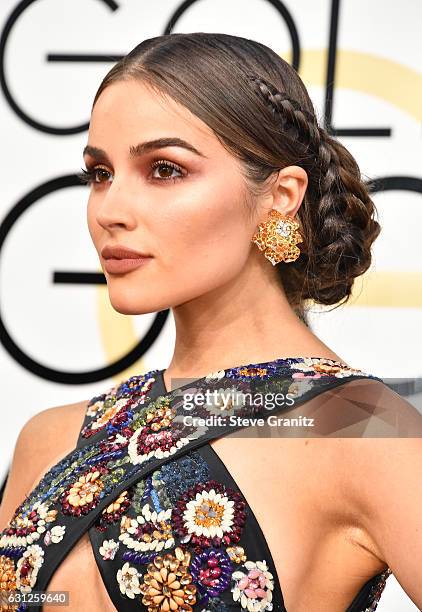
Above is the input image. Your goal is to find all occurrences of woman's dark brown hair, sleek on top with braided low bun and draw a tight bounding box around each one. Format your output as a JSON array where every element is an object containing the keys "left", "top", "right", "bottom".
[{"left": 93, "top": 32, "right": 380, "bottom": 322}]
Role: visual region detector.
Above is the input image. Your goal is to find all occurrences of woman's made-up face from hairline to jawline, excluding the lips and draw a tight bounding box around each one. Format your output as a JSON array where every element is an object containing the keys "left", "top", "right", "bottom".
[{"left": 84, "top": 80, "right": 264, "bottom": 314}]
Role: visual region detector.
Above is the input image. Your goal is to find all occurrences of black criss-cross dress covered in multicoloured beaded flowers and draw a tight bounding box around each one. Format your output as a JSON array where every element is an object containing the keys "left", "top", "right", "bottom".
[{"left": 0, "top": 357, "right": 391, "bottom": 612}]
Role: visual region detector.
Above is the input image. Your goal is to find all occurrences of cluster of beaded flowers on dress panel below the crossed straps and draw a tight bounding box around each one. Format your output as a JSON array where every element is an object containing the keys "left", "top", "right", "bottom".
[{"left": 104, "top": 450, "right": 274, "bottom": 612}]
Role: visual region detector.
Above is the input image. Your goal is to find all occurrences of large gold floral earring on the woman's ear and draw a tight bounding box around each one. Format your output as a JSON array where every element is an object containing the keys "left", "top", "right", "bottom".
[{"left": 252, "top": 209, "right": 303, "bottom": 266}]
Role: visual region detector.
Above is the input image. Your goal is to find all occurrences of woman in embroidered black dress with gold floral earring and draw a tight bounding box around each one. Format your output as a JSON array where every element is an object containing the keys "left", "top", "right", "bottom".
[{"left": 0, "top": 33, "right": 422, "bottom": 612}]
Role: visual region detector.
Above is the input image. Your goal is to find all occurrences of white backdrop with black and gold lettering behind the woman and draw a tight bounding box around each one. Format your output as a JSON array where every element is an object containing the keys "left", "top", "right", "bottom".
[{"left": 0, "top": 0, "right": 422, "bottom": 612}]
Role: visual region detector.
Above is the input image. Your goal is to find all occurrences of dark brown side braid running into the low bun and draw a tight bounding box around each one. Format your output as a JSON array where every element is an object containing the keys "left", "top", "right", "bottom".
[{"left": 249, "top": 75, "right": 381, "bottom": 316}]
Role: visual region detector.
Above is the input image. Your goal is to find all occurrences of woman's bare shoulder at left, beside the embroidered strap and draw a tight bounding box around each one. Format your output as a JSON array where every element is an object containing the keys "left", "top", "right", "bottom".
[{"left": 0, "top": 400, "right": 88, "bottom": 531}]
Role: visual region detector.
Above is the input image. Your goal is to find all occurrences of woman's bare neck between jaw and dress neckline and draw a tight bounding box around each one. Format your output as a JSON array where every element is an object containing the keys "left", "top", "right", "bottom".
[{"left": 165, "top": 264, "right": 343, "bottom": 382}]
